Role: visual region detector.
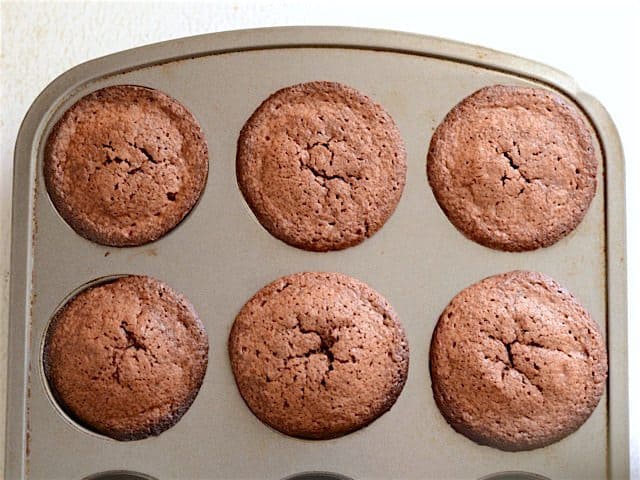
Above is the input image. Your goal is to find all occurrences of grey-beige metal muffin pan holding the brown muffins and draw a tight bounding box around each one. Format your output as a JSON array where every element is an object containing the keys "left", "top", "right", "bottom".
[{"left": 5, "top": 27, "right": 629, "bottom": 480}]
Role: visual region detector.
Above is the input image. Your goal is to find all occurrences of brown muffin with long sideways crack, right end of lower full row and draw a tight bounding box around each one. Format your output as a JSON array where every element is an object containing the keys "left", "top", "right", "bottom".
[{"left": 430, "top": 271, "right": 607, "bottom": 451}]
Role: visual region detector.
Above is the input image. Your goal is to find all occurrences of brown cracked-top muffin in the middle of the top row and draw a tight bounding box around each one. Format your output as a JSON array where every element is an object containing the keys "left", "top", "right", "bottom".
[{"left": 236, "top": 82, "right": 406, "bottom": 251}]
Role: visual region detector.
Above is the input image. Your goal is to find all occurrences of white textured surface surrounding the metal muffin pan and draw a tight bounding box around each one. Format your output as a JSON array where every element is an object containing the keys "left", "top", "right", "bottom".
[{"left": 0, "top": 0, "right": 640, "bottom": 480}]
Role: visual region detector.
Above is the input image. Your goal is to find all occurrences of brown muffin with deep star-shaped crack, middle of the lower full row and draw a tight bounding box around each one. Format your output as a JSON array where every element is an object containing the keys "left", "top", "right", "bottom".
[{"left": 229, "top": 272, "right": 409, "bottom": 439}]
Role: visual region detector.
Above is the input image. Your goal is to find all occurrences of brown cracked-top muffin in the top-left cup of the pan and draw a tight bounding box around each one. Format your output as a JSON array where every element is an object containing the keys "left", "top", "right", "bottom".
[{"left": 44, "top": 85, "right": 209, "bottom": 247}]
